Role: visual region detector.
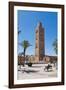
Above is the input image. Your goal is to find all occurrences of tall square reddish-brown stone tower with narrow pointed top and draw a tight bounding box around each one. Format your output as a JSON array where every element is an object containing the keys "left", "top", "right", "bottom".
[{"left": 35, "top": 22, "right": 45, "bottom": 62}]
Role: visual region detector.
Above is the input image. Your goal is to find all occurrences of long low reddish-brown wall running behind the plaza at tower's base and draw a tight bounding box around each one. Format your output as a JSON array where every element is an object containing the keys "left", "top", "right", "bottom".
[{"left": 18, "top": 56, "right": 57, "bottom": 64}]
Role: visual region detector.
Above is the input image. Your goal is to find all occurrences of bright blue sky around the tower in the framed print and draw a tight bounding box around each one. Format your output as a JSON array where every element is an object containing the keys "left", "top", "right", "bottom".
[{"left": 17, "top": 10, "right": 57, "bottom": 55}]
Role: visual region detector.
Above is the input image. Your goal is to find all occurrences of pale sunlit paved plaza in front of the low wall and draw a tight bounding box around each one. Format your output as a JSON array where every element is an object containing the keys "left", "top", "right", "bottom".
[{"left": 17, "top": 64, "right": 57, "bottom": 80}]
